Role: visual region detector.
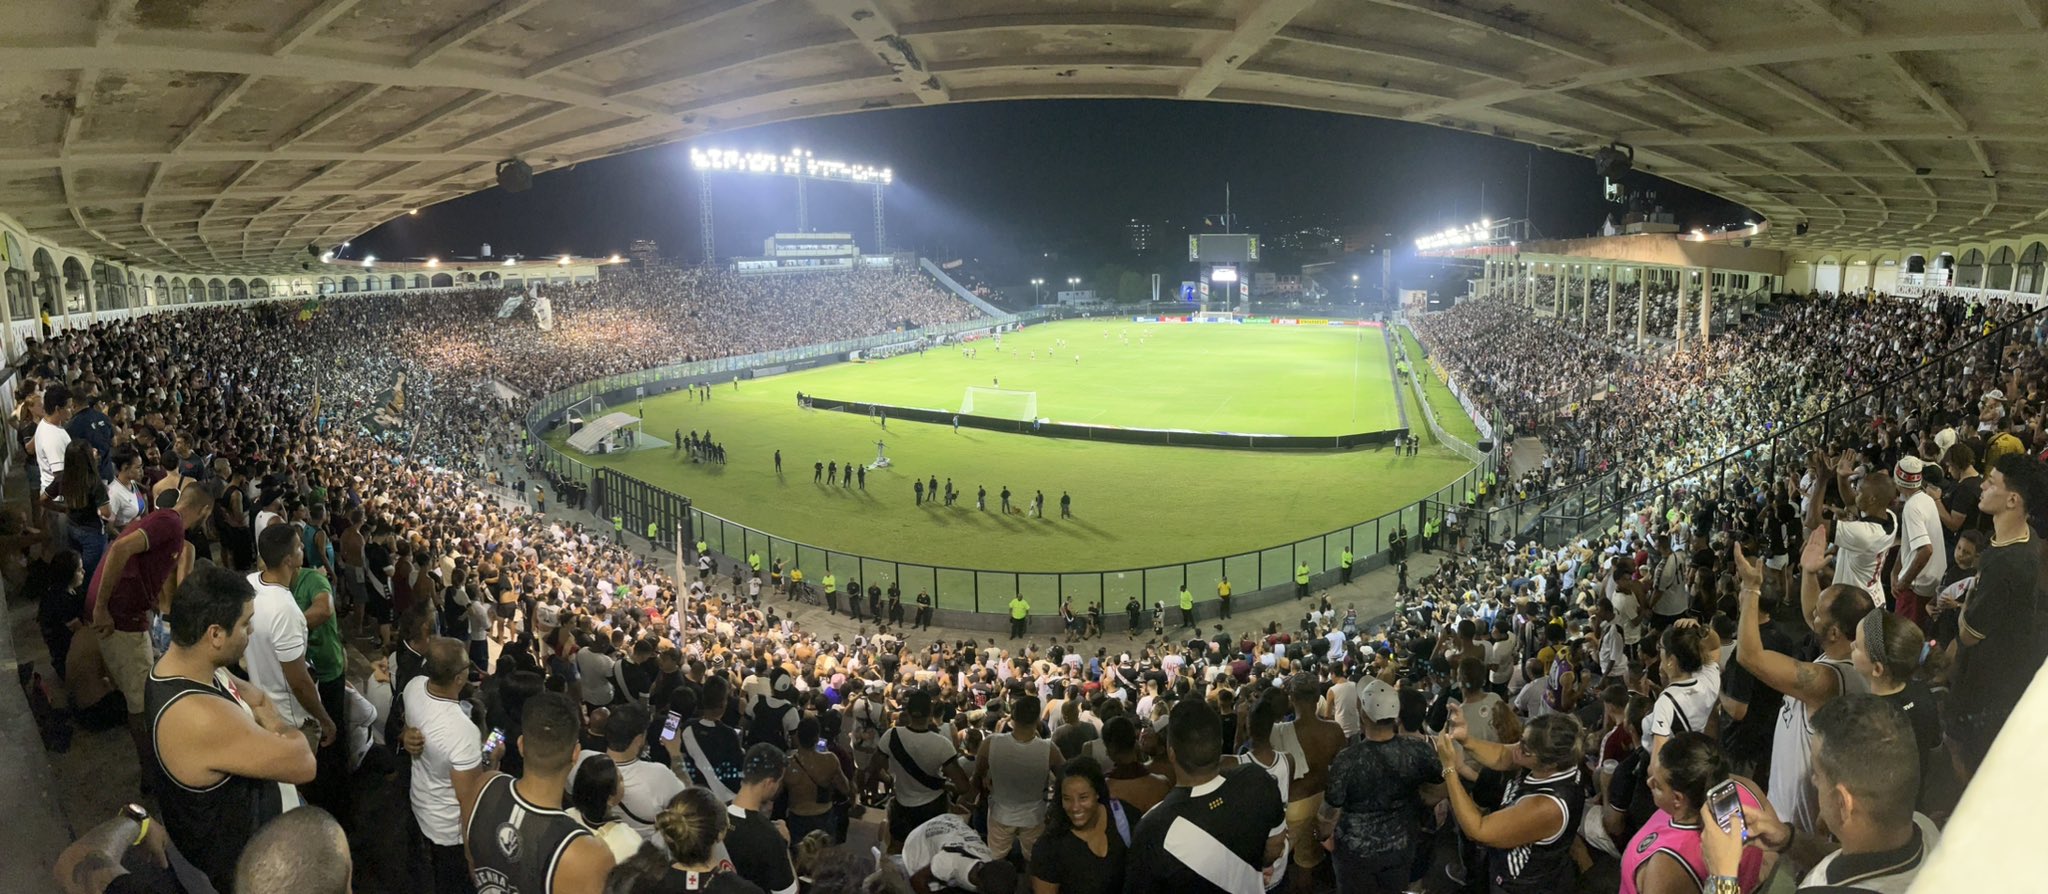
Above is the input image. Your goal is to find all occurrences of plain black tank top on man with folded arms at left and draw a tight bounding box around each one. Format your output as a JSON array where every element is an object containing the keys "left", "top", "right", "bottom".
[{"left": 143, "top": 671, "right": 285, "bottom": 892}]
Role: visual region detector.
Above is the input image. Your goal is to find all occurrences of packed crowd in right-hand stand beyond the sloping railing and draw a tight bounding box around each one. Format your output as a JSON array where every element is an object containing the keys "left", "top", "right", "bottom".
[{"left": 1417, "top": 288, "right": 2025, "bottom": 505}]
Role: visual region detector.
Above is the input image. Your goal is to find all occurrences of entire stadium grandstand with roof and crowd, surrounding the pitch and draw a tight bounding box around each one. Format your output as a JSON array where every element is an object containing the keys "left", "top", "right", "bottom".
[{"left": 0, "top": 0, "right": 2048, "bottom": 894}]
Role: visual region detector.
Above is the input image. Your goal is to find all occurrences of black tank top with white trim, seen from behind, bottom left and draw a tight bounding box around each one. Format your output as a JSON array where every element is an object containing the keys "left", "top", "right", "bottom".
[{"left": 463, "top": 775, "right": 590, "bottom": 894}]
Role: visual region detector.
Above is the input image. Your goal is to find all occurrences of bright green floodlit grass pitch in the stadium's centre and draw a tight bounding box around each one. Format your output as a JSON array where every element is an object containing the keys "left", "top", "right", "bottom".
[{"left": 551, "top": 321, "right": 1468, "bottom": 580}]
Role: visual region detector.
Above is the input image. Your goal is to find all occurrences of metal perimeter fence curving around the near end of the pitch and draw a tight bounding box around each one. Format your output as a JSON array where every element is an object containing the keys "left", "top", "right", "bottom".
[{"left": 526, "top": 302, "right": 1487, "bottom": 614}]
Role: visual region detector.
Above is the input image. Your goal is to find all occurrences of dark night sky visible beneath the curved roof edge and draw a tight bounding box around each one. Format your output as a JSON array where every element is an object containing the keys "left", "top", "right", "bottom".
[{"left": 348, "top": 100, "right": 1749, "bottom": 276}]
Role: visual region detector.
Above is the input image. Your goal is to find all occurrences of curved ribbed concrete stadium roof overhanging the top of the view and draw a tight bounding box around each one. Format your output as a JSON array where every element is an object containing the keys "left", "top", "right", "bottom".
[{"left": 0, "top": 0, "right": 2048, "bottom": 272}]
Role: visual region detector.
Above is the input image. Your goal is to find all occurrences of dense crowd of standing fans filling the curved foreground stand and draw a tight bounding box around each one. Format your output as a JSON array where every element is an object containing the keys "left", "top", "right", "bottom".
[{"left": 16, "top": 272, "right": 2048, "bottom": 894}]
